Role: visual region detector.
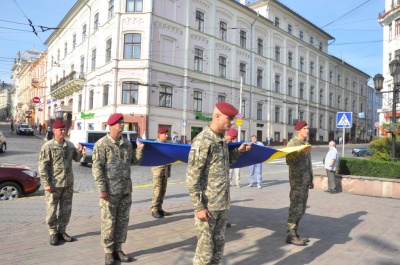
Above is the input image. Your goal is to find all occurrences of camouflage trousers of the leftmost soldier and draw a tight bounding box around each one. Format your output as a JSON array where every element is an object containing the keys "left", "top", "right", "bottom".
[{"left": 45, "top": 187, "right": 74, "bottom": 235}]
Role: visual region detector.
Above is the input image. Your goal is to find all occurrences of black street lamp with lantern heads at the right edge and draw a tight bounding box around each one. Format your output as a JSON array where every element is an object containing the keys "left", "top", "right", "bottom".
[{"left": 374, "top": 59, "right": 400, "bottom": 162}]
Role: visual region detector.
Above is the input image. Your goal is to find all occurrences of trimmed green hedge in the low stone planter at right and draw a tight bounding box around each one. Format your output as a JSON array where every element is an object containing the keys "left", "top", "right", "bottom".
[{"left": 337, "top": 157, "right": 400, "bottom": 179}]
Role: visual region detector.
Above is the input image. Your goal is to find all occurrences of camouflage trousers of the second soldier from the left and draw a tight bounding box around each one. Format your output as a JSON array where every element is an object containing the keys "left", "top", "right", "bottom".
[{"left": 99, "top": 193, "right": 132, "bottom": 253}]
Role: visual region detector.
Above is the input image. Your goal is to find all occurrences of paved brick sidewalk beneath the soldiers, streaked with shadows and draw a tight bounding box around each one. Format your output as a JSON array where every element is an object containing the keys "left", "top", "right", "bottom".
[{"left": 0, "top": 179, "right": 400, "bottom": 265}]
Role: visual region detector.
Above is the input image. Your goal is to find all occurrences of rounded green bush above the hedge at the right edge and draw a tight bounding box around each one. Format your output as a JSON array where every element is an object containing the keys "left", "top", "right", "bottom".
[{"left": 368, "top": 136, "right": 400, "bottom": 161}]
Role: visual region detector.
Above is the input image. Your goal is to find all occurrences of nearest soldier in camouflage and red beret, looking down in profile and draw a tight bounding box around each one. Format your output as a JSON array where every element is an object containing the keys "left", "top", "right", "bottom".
[{"left": 186, "top": 102, "right": 250, "bottom": 265}]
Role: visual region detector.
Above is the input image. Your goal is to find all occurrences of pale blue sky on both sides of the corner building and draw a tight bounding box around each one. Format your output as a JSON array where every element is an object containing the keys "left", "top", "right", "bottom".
[{"left": 0, "top": 0, "right": 385, "bottom": 85}]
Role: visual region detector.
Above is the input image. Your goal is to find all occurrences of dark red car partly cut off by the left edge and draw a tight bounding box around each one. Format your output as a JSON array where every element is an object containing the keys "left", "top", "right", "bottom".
[{"left": 0, "top": 163, "right": 40, "bottom": 201}]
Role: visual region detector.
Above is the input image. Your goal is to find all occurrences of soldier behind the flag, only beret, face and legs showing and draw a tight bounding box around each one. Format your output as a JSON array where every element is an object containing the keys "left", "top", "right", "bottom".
[{"left": 151, "top": 127, "right": 172, "bottom": 218}]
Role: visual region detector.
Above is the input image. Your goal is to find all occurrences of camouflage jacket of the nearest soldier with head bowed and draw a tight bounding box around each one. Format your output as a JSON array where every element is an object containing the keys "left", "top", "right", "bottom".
[{"left": 186, "top": 127, "right": 240, "bottom": 212}]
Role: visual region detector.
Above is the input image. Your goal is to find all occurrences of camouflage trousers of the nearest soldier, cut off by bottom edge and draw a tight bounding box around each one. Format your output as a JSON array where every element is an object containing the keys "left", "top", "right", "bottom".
[{"left": 193, "top": 210, "right": 228, "bottom": 265}]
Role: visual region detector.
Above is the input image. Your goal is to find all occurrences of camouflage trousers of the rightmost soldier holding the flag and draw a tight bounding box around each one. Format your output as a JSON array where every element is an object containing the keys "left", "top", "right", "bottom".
[{"left": 286, "top": 186, "right": 309, "bottom": 236}]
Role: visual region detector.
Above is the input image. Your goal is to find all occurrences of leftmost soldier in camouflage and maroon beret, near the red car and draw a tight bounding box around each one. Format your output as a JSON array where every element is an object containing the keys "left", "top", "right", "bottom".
[{"left": 39, "top": 120, "right": 82, "bottom": 245}]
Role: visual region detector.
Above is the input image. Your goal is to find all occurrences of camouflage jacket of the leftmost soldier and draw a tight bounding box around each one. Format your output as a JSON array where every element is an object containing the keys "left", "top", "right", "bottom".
[{"left": 39, "top": 139, "right": 82, "bottom": 187}]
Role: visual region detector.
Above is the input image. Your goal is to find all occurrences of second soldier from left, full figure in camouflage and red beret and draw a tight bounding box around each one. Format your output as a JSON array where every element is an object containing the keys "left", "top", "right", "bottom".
[{"left": 92, "top": 113, "right": 144, "bottom": 265}]
